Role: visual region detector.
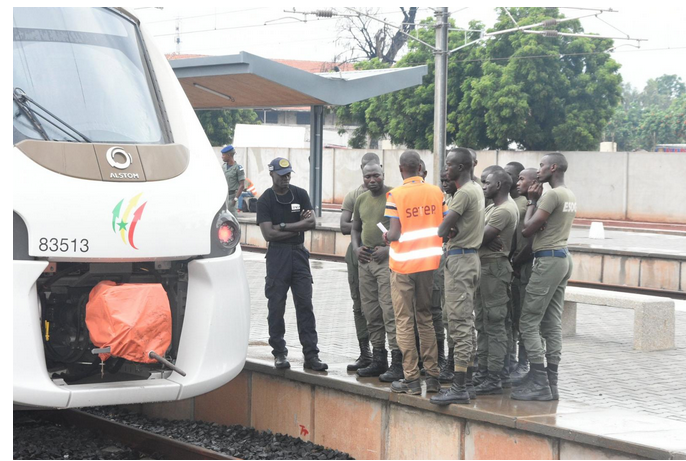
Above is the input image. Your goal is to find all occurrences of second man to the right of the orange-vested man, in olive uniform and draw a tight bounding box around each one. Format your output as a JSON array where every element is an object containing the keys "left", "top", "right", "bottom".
[{"left": 474, "top": 167, "right": 519, "bottom": 395}]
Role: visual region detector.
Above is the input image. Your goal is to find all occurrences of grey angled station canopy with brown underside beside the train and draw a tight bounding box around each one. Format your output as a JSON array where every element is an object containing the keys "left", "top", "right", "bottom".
[{"left": 170, "top": 51, "right": 427, "bottom": 110}]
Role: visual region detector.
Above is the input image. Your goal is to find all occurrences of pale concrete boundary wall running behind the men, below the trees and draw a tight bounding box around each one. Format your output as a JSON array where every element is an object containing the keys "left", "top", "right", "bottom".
[{"left": 215, "top": 147, "right": 686, "bottom": 224}]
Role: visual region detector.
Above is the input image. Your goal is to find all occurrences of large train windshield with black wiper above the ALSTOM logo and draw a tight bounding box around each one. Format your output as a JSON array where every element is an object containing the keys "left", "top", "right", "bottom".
[{"left": 13, "top": 8, "right": 168, "bottom": 144}]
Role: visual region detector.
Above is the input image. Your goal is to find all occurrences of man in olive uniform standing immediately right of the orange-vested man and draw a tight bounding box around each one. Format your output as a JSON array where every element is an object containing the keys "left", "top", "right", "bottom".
[{"left": 431, "top": 147, "right": 485, "bottom": 405}]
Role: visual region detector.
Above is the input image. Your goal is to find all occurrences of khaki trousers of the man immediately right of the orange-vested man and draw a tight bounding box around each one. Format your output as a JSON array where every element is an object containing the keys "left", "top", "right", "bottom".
[{"left": 445, "top": 253, "right": 481, "bottom": 371}]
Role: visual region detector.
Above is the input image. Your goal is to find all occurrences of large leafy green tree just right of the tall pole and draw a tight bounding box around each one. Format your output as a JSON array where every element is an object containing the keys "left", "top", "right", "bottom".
[{"left": 457, "top": 8, "right": 621, "bottom": 150}]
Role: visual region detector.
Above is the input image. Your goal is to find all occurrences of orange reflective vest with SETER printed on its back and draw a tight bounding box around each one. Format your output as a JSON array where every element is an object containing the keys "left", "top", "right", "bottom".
[{"left": 386, "top": 176, "right": 448, "bottom": 274}]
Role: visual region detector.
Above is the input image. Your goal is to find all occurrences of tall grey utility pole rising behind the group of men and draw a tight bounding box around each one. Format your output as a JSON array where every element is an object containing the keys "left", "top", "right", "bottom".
[{"left": 434, "top": 7, "right": 448, "bottom": 179}]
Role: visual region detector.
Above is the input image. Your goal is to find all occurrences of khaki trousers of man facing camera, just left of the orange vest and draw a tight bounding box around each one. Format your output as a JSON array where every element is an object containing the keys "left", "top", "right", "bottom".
[{"left": 358, "top": 260, "right": 398, "bottom": 350}]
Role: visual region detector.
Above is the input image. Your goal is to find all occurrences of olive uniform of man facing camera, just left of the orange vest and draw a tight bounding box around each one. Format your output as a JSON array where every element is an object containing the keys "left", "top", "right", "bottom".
[{"left": 353, "top": 187, "right": 398, "bottom": 350}]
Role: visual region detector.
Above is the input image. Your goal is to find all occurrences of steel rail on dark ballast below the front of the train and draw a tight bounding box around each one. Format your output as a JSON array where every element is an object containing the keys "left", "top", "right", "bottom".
[{"left": 38, "top": 410, "right": 240, "bottom": 459}]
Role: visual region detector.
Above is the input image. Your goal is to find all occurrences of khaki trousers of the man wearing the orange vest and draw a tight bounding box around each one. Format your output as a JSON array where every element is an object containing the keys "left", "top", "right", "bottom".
[{"left": 391, "top": 271, "right": 440, "bottom": 381}]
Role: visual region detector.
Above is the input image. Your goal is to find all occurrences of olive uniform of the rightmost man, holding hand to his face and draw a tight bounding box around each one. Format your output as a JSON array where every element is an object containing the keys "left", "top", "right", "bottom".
[{"left": 519, "top": 186, "right": 576, "bottom": 364}]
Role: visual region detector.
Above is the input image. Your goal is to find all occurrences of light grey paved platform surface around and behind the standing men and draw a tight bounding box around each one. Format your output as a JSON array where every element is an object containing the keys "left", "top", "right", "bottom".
[{"left": 243, "top": 252, "right": 686, "bottom": 422}]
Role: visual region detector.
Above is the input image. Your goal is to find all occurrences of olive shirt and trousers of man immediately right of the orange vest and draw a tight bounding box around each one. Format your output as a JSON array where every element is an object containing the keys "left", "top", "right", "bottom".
[{"left": 445, "top": 181, "right": 485, "bottom": 371}]
